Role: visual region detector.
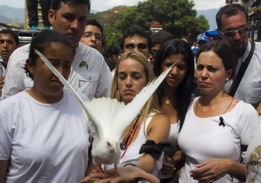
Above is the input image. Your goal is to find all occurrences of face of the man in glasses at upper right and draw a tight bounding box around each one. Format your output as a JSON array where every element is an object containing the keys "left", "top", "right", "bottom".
[{"left": 217, "top": 12, "right": 248, "bottom": 58}]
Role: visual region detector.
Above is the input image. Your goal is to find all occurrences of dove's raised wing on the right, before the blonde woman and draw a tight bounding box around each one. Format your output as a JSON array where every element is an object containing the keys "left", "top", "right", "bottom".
[{"left": 113, "top": 61, "right": 177, "bottom": 138}]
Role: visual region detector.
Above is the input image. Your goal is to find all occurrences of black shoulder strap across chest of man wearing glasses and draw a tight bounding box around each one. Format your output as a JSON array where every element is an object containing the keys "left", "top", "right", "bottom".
[{"left": 229, "top": 42, "right": 255, "bottom": 96}]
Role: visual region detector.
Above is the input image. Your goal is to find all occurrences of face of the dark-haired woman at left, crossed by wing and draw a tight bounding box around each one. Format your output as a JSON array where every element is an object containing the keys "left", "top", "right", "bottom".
[{"left": 29, "top": 43, "right": 74, "bottom": 101}]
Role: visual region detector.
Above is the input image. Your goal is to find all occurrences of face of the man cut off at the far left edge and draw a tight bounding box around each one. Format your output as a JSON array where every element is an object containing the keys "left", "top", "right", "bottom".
[{"left": 0, "top": 34, "right": 18, "bottom": 63}]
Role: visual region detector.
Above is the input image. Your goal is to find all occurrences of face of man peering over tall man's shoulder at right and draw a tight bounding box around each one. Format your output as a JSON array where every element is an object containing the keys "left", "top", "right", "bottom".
[{"left": 81, "top": 25, "right": 103, "bottom": 53}]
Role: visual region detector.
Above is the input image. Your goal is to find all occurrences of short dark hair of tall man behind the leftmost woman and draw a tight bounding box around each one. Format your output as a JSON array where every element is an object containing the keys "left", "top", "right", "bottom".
[{"left": 51, "top": 0, "right": 91, "bottom": 13}]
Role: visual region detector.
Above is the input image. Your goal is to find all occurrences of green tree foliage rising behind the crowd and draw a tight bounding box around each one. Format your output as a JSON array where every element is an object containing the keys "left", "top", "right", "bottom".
[{"left": 90, "top": 0, "right": 209, "bottom": 48}]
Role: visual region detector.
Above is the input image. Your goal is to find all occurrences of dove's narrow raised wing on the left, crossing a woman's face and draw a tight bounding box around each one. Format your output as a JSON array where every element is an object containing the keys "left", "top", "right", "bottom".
[{"left": 35, "top": 49, "right": 98, "bottom": 135}]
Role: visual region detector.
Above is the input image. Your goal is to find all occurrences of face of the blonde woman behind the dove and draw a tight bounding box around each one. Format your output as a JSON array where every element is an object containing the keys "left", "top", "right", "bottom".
[{"left": 117, "top": 58, "right": 147, "bottom": 104}]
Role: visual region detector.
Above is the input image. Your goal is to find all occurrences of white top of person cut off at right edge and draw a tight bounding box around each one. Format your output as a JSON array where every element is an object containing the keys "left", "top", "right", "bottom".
[{"left": 244, "top": 117, "right": 261, "bottom": 183}]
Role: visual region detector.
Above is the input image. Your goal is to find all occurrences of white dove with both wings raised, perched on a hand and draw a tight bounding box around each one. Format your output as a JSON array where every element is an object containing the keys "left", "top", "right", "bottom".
[{"left": 35, "top": 50, "right": 176, "bottom": 170}]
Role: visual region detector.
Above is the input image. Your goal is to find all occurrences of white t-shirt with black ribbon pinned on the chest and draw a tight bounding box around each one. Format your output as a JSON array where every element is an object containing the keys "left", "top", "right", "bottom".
[{"left": 178, "top": 98, "right": 258, "bottom": 183}]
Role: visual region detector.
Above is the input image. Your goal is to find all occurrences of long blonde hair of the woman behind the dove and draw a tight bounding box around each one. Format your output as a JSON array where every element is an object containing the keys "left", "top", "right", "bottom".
[{"left": 111, "top": 51, "right": 161, "bottom": 119}]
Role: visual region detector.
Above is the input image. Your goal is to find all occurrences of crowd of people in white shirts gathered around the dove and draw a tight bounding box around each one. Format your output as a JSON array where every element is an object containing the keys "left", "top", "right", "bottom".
[{"left": 0, "top": 0, "right": 261, "bottom": 183}]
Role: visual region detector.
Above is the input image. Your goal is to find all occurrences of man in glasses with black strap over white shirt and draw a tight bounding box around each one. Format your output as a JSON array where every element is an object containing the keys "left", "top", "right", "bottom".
[{"left": 216, "top": 4, "right": 261, "bottom": 114}]
